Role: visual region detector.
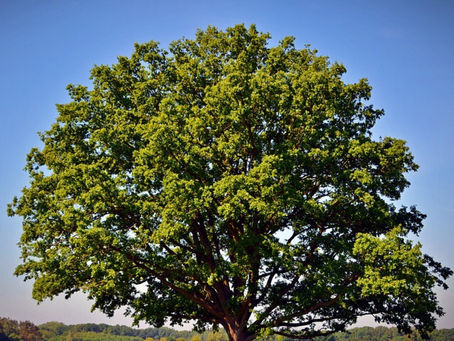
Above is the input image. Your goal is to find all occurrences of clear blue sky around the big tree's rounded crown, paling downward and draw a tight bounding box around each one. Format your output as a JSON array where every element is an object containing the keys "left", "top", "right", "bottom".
[{"left": 0, "top": 0, "right": 454, "bottom": 328}]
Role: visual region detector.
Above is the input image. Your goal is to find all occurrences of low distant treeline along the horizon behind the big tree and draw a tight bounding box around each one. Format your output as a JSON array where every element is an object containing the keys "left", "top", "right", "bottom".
[{"left": 0, "top": 318, "right": 454, "bottom": 341}]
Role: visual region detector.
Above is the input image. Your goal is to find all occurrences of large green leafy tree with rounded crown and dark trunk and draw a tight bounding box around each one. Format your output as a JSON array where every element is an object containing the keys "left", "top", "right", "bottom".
[{"left": 10, "top": 25, "right": 451, "bottom": 340}]
